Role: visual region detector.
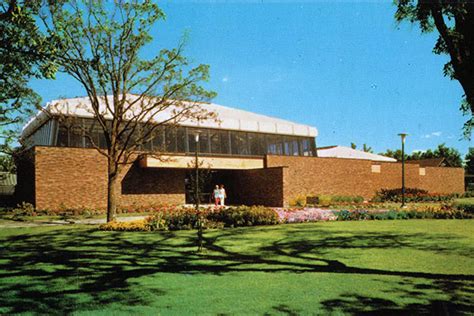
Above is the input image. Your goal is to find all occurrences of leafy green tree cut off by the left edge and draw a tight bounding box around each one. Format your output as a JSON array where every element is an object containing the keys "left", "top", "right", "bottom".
[{"left": 0, "top": 0, "right": 57, "bottom": 154}]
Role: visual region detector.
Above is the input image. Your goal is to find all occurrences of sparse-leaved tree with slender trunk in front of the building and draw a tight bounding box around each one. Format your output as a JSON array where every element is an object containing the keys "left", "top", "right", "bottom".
[{"left": 41, "top": 0, "right": 215, "bottom": 221}]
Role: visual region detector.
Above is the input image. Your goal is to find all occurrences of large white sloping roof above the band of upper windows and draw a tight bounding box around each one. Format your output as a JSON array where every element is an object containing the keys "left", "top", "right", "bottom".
[{"left": 22, "top": 94, "right": 318, "bottom": 138}]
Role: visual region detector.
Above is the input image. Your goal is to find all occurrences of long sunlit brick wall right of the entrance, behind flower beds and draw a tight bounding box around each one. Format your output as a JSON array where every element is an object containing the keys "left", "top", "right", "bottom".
[{"left": 266, "top": 155, "right": 464, "bottom": 201}]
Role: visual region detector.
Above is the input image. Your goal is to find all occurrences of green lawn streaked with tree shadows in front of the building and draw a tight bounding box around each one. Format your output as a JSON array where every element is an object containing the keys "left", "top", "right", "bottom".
[{"left": 0, "top": 220, "right": 474, "bottom": 315}]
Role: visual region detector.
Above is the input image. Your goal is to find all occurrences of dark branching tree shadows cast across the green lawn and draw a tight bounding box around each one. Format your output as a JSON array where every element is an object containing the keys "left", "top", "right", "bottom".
[{"left": 0, "top": 226, "right": 474, "bottom": 315}]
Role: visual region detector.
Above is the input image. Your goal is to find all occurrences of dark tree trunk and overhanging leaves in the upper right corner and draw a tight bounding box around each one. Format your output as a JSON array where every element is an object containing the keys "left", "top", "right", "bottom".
[{"left": 395, "top": 0, "right": 474, "bottom": 139}]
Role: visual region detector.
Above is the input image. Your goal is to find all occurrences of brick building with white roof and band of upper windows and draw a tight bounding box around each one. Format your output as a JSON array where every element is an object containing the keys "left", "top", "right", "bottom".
[{"left": 17, "top": 96, "right": 464, "bottom": 209}]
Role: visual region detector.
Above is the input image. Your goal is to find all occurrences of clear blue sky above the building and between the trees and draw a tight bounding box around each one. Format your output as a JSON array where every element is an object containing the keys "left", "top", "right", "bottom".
[{"left": 32, "top": 0, "right": 474, "bottom": 155}]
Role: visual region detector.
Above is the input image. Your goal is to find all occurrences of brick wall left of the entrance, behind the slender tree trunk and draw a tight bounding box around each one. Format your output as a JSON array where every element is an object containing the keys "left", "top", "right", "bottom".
[{"left": 29, "top": 147, "right": 184, "bottom": 209}]
